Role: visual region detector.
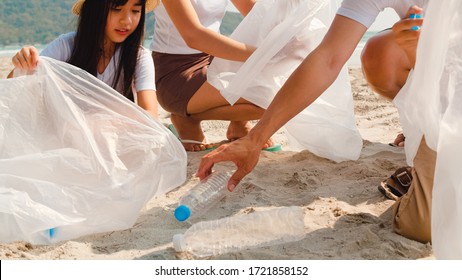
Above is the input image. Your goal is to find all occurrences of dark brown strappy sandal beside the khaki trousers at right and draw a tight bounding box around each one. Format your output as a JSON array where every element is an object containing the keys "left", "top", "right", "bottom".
[{"left": 378, "top": 167, "right": 412, "bottom": 200}]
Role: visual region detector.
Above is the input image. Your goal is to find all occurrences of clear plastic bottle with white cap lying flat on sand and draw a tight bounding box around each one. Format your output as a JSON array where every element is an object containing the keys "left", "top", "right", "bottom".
[{"left": 173, "top": 206, "right": 305, "bottom": 257}]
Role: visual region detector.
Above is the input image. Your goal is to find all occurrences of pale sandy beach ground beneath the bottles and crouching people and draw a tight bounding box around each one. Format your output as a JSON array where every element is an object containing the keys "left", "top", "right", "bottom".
[{"left": 0, "top": 58, "right": 433, "bottom": 260}]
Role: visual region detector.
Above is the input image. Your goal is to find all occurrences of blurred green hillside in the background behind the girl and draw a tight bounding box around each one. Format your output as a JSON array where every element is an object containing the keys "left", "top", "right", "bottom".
[{"left": 0, "top": 0, "right": 242, "bottom": 46}]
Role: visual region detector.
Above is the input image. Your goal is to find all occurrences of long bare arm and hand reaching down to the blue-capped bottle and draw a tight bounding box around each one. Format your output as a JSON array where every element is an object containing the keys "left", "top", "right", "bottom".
[{"left": 197, "top": 15, "right": 366, "bottom": 191}]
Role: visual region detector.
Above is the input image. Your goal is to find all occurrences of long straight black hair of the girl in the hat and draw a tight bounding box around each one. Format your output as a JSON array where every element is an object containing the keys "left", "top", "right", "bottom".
[{"left": 68, "top": 0, "right": 146, "bottom": 101}]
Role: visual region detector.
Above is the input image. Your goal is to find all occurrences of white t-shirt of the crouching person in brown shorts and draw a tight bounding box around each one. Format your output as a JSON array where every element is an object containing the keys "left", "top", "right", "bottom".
[{"left": 150, "top": 0, "right": 229, "bottom": 54}]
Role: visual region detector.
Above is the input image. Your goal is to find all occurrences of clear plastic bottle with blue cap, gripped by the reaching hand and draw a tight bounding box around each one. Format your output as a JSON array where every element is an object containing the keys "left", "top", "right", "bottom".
[{"left": 174, "top": 171, "right": 231, "bottom": 222}]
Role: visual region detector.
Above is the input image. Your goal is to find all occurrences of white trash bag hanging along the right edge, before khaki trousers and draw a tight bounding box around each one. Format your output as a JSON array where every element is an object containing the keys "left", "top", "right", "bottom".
[{"left": 395, "top": 0, "right": 462, "bottom": 259}]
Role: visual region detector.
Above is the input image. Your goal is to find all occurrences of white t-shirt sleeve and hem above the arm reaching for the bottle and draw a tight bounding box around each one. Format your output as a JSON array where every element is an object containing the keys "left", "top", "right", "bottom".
[{"left": 337, "top": 0, "right": 428, "bottom": 28}]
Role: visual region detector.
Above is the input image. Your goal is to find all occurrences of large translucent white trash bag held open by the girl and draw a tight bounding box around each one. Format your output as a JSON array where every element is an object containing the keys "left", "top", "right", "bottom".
[{"left": 0, "top": 58, "right": 186, "bottom": 244}]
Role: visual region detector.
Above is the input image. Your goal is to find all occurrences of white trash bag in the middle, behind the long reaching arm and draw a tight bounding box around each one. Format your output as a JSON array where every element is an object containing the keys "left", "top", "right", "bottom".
[{"left": 207, "top": 0, "right": 362, "bottom": 161}]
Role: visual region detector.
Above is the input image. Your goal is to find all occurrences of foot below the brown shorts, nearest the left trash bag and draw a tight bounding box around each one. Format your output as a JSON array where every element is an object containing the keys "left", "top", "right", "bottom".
[{"left": 170, "top": 114, "right": 207, "bottom": 152}]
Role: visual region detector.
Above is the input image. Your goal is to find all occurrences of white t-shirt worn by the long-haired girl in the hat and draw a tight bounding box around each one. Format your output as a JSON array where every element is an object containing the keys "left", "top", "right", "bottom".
[{"left": 40, "top": 32, "right": 156, "bottom": 93}]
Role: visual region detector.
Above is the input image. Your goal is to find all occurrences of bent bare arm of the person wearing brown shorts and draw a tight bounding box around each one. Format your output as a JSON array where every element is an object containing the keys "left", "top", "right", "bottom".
[{"left": 162, "top": 0, "right": 255, "bottom": 61}]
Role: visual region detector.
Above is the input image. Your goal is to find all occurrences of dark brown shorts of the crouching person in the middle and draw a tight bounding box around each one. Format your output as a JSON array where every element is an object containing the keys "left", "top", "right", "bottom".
[{"left": 152, "top": 52, "right": 212, "bottom": 116}]
